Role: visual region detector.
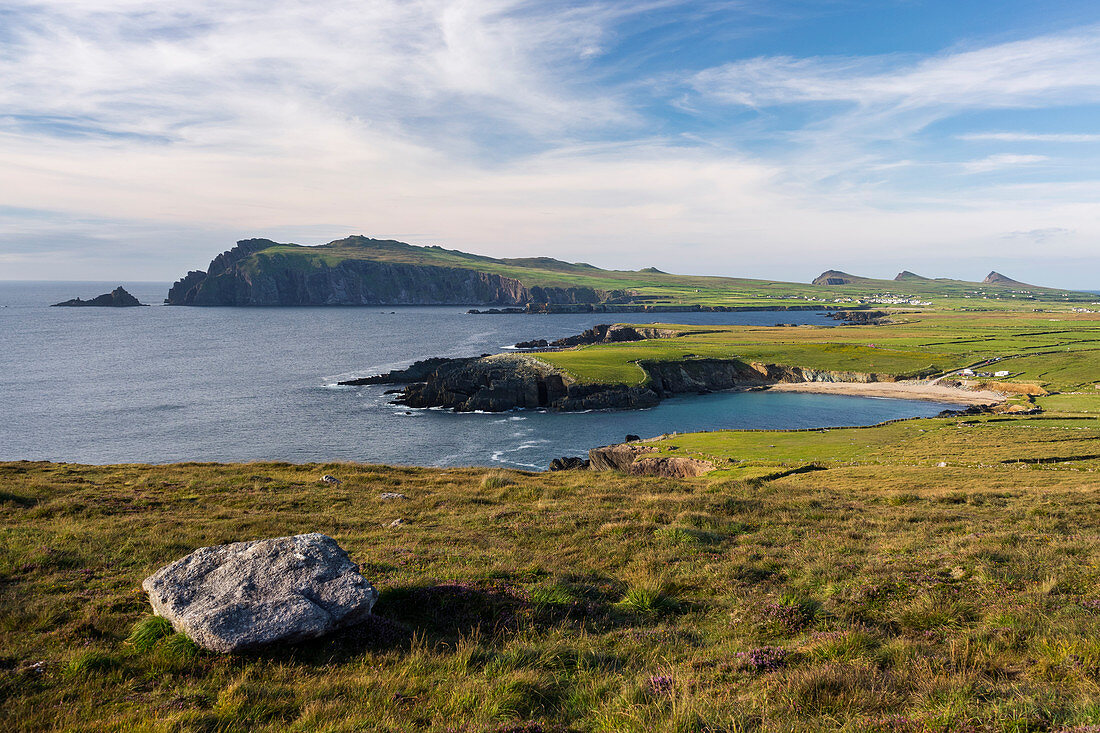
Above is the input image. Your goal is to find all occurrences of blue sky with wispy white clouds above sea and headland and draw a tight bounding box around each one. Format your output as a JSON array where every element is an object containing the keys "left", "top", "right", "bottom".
[{"left": 0, "top": 0, "right": 1100, "bottom": 288}]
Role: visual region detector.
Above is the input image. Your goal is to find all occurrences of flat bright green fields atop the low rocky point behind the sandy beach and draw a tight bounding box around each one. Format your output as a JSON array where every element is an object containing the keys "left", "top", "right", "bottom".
[{"left": 538, "top": 311, "right": 1100, "bottom": 391}]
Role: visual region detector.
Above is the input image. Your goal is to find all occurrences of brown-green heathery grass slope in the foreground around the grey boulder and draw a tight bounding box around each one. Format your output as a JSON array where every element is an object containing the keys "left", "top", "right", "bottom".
[{"left": 0, "top": 451, "right": 1100, "bottom": 731}]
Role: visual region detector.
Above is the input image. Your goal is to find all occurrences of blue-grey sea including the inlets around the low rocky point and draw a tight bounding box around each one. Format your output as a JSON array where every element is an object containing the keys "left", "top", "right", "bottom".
[{"left": 0, "top": 282, "right": 948, "bottom": 469}]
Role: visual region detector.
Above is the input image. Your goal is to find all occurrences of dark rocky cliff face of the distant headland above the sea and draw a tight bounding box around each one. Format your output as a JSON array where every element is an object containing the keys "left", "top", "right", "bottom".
[{"left": 166, "top": 239, "right": 603, "bottom": 306}]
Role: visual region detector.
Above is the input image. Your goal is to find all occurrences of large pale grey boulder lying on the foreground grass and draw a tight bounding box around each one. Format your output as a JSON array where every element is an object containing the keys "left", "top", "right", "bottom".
[{"left": 142, "top": 533, "right": 378, "bottom": 652}]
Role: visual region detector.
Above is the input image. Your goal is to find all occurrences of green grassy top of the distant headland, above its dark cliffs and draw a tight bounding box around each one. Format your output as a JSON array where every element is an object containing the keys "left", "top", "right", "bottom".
[{"left": 242, "top": 237, "right": 1096, "bottom": 310}]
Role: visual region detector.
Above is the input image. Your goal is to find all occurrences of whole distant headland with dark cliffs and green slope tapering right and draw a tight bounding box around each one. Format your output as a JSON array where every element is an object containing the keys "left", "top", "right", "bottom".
[{"left": 165, "top": 236, "right": 1096, "bottom": 305}]
